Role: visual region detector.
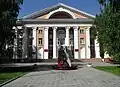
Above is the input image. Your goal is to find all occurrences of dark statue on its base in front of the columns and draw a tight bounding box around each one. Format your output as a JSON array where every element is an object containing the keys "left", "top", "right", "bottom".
[{"left": 57, "top": 37, "right": 77, "bottom": 70}]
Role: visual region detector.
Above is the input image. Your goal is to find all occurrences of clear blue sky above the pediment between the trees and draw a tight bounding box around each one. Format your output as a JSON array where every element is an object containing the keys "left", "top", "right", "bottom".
[{"left": 19, "top": 0, "right": 100, "bottom": 18}]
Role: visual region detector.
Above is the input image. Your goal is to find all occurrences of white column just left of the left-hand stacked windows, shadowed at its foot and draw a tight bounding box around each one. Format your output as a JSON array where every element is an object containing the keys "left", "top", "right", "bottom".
[{"left": 32, "top": 27, "right": 37, "bottom": 59}]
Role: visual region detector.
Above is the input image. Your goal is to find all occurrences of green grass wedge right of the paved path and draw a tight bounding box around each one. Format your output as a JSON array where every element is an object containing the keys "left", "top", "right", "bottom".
[{"left": 94, "top": 66, "right": 120, "bottom": 76}]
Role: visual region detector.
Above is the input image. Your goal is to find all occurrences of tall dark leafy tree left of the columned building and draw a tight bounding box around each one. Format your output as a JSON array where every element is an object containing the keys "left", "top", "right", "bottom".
[{"left": 0, "top": 0, "right": 23, "bottom": 57}]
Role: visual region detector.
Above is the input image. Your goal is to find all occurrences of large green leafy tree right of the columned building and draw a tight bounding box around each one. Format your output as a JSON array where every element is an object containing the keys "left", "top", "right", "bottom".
[{"left": 95, "top": 0, "right": 120, "bottom": 63}]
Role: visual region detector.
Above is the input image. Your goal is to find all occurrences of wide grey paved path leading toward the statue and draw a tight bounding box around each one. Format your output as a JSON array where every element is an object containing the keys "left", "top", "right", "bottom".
[{"left": 3, "top": 67, "right": 120, "bottom": 87}]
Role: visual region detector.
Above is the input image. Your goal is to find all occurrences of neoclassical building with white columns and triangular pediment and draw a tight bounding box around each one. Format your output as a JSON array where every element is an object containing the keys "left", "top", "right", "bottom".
[{"left": 14, "top": 3, "right": 107, "bottom": 59}]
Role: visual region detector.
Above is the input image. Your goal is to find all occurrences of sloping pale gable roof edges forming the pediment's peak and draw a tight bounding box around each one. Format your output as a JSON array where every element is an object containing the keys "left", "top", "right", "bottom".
[{"left": 22, "top": 3, "right": 95, "bottom": 19}]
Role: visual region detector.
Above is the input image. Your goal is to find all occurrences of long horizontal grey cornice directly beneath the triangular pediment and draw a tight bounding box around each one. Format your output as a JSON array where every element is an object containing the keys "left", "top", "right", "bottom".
[{"left": 17, "top": 18, "right": 94, "bottom": 24}]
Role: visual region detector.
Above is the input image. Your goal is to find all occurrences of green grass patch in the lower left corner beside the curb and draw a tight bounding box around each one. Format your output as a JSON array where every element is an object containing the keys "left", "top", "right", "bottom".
[{"left": 0, "top": 72, "right": 24, "bottom": 84}]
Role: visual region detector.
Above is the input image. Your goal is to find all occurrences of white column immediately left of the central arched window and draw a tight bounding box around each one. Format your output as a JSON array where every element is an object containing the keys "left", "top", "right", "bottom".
[{"left": 53, "top": 27, "right": 57, "bottom": 59}]
